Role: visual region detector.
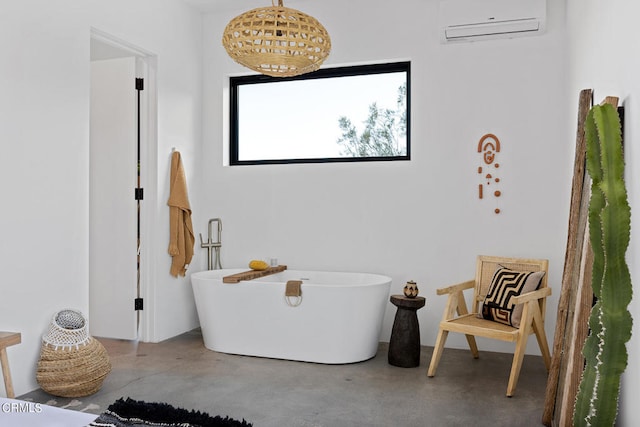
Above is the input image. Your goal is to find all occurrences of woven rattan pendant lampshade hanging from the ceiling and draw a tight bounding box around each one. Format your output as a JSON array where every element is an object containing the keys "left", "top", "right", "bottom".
[{"left": 222, "top": 0, "right": 331, "bottom": 77}]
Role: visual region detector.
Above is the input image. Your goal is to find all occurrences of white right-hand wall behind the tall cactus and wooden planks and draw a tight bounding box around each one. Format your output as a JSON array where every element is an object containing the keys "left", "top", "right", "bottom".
[{"left": 567, "top": 0, "right": 640, "bottom": 426}]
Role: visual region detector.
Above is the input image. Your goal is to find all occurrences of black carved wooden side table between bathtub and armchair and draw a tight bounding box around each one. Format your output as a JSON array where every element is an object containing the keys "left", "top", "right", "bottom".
[{"left": 389, "top": 295, "right": 426, "bottom": 368}]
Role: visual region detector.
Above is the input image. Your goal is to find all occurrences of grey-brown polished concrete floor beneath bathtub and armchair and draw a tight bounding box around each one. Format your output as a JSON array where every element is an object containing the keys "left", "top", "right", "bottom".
[{"left": 19, "top": 330, "right": 546, "bottom": 427}]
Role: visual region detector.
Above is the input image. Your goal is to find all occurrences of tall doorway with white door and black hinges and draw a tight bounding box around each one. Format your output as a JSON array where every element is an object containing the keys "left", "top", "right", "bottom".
[{"left": 89, "top": 29, "right": 157, "bottom": 341}]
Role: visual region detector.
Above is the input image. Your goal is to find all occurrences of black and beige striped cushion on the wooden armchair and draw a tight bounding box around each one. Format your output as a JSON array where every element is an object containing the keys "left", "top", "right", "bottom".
[{"left": 482, "top": 267, "right": 544, "bottom": 328}]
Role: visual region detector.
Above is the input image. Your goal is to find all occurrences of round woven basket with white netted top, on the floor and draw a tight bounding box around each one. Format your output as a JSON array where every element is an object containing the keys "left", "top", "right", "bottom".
[{"left": 36, "top": 310, "right": 111, "bottom": 397}]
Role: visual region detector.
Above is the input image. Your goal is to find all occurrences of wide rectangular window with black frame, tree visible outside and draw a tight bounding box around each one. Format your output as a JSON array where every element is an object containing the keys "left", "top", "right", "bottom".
[{"left": 229, "top": 62, "right": 411, "bottom": 165}]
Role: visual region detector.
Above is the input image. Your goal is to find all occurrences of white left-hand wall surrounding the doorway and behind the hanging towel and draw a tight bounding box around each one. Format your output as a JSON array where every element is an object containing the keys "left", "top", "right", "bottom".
[{"left": 0, "top": 0, "right": 202, "bottom": 395}]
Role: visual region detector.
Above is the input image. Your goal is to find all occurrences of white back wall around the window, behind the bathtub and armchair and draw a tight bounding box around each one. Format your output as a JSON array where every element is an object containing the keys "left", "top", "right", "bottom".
[{"left": 201, "top": 0, "right": 575, "bottom": 353}]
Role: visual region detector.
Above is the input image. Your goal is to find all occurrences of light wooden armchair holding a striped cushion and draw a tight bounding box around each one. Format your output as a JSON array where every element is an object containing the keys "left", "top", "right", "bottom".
[{"left": 427, "top": 256, "right": 551, "bottom": 397}]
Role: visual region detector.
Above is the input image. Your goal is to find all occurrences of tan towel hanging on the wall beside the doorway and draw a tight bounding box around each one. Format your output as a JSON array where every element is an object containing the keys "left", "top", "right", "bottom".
[{"left": 167, "top": 151, "right": 195, "bottom": 277}]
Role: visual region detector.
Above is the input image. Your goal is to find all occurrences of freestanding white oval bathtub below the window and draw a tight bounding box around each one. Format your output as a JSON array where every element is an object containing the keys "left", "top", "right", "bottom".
[{"left": 191, "top": 269, "right": 391, "bottom": 364}]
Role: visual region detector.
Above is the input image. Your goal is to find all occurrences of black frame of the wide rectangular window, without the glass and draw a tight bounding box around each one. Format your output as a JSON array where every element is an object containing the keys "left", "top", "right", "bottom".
[{"left": 229, "top": 61, "right": 411, "bottom": 166}]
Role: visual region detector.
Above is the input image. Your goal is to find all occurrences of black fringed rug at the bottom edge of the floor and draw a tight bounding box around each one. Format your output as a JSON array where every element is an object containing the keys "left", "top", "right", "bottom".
[{"left": 89, "top": 398, "right": 253, "bottom": 427}]
